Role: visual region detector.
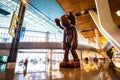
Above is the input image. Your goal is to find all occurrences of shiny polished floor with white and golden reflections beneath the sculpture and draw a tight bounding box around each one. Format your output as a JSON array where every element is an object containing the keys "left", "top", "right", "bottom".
[{"left": 0, "top": 61, "right": 120, "bottom": 80}]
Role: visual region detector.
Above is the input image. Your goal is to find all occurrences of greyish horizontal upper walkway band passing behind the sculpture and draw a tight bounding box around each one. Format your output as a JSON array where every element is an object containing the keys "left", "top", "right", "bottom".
[{"left": 0, "top": 42, "right": 97, "bottom": 55}]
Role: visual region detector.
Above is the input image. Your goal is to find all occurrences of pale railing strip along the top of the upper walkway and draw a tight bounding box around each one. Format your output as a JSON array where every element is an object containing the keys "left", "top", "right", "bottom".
[{"left": 0, "top": 33, "right": 63, "bottom": 43}]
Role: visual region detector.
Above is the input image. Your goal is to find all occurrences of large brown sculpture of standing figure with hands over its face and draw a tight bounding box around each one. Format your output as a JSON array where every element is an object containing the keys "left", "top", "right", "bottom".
[{"left": 55, "top": 12, "right": 80, "bottom": 67}]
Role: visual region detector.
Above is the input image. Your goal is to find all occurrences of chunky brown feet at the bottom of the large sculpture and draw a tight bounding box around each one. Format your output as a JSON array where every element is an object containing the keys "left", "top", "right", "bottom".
[{"left": 60, "top": 61, "right": 80, "bottom": 68}]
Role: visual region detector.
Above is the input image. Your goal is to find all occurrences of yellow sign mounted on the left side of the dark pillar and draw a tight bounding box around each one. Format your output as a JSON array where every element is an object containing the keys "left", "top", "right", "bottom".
[{"left": 9, "top": 11, "right": 18, "bottom": 38}]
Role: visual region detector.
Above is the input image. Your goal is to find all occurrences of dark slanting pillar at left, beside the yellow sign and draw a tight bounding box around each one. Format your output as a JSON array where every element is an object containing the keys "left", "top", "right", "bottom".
[{"left": 8, "top": 1, "right": 26, "bottom": 63}]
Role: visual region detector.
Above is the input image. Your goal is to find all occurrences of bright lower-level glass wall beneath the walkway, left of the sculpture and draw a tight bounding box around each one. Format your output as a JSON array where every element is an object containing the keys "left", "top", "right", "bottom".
[{"left": 17, "top": 49, "right": 64, "bottom": 62}]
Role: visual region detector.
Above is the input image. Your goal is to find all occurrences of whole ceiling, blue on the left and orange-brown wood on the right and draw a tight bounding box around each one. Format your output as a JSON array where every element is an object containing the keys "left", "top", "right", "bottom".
[{"left": 0, "top": 0, "right": 120, "bottom": 44}]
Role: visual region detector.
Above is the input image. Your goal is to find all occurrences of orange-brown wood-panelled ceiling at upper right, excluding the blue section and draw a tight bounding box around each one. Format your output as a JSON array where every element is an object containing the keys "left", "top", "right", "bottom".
[{"left": 57, "top": 0, "right": 120, "bottom": 42}]
